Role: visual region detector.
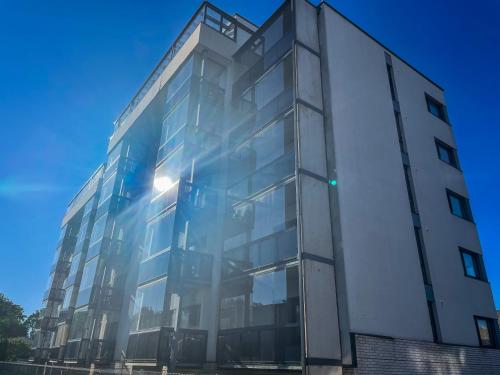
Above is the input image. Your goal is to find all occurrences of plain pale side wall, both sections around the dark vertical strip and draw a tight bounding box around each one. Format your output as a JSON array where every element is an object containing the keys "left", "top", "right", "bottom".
[{"left": 320, "top": 5, "right": 496, "bottom": 346}]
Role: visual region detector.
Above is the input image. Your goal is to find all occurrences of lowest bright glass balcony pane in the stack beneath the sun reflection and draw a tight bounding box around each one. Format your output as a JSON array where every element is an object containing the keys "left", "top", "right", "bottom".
[{"left": 132, "top": 278, "right": 167, "bottom": 331}]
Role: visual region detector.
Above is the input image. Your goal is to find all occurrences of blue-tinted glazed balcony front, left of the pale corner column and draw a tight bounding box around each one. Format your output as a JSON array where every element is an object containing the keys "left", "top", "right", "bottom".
[{"left": 37, "top": 3, "right": 300, "bottom": 364}]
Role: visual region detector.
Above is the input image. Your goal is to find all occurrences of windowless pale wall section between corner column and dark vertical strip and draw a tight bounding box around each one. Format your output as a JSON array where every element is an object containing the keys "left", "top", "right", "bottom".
[{"left": 320, "top": 5, "right": 432, "bottom": 340}]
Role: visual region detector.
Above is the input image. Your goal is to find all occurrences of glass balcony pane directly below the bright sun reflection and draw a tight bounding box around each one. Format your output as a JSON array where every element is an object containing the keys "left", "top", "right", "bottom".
[{"left": 144, "top": 210, "right": 175, "bottom": 258}]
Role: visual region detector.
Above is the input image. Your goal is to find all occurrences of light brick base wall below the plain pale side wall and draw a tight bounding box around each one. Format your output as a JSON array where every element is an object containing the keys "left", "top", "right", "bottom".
[{"left": 343, "top": 335, "right": 500, "bottom": 375}]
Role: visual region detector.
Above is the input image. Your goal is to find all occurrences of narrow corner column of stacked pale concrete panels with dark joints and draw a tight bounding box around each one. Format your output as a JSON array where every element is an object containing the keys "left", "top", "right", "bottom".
[{"left": 294, "top": 0, "right": 342, "bottom": 374}]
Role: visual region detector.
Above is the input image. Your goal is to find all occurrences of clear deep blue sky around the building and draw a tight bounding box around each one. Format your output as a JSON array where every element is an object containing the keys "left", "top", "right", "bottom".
[{"left": 0, "top": 0, "right": 500, "bottom": 313}]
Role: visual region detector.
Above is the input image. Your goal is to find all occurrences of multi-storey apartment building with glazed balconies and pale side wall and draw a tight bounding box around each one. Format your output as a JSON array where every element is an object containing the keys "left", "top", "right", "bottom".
[{"left": 35, "top": 0, "right": 500, "bottom": 375}]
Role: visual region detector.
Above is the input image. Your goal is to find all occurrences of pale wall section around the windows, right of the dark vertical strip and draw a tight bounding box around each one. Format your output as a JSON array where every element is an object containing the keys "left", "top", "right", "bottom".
[{"left": 393, "top": 57, "right": 496, "bottom": 345}]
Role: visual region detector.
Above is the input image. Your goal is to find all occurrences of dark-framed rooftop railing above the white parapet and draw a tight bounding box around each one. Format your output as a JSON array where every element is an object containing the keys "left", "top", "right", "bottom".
[{"left": 114, "top": 2, "right": 247, "bottom": 131}]
